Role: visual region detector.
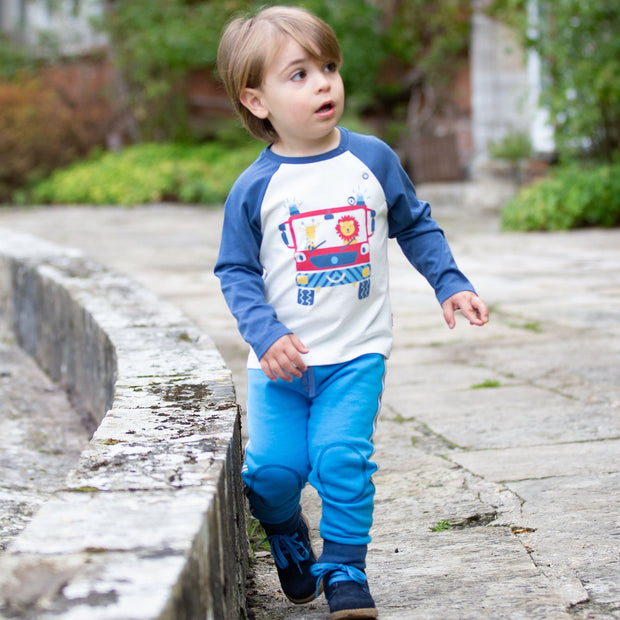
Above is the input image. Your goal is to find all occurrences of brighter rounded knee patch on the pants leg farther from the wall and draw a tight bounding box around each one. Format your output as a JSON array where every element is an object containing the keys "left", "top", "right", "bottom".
[{"left": 311, "top": 441, "right": 377, "bottom": 504}]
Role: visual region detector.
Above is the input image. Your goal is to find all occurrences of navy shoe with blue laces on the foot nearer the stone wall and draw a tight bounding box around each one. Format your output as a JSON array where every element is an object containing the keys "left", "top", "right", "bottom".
[{"left": 262, "top": 514, "right": 323, "bottom": 605}]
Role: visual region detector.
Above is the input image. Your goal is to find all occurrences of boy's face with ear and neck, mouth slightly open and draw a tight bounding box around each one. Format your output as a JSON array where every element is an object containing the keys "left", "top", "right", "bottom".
[{"left": 241, "top": 37, "right": 344, "bottom": 156}]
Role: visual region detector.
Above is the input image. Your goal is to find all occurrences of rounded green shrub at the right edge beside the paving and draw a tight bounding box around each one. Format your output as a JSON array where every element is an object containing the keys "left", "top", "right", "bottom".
[{"left": 502, "top": 163, "right": 620, "bottom": 231}]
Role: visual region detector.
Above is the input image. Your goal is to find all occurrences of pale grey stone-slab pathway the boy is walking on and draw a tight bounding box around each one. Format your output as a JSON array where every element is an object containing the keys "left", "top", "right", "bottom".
[{"left": 0, "top": 184, "right": 620, "bottom": 620}]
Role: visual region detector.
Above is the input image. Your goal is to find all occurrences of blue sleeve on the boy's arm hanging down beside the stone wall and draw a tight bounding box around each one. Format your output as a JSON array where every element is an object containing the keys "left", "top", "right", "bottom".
[{"left": 214, "top": 165, "right": 291, "bottom": 359}]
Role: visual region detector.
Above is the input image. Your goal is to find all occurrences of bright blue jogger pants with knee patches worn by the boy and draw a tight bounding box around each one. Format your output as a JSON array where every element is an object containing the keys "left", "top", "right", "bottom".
[{"left": 243, "top": 354, "right": 385, "bottom": 545}]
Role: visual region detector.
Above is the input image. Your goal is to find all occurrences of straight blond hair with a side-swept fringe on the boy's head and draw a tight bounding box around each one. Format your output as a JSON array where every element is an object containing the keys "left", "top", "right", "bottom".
[{"left": 217, "top": 6, "right": 342, "bottom": 142}]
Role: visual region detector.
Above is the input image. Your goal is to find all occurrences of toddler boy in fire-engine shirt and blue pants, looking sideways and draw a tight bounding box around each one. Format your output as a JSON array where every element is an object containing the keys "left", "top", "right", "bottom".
[{"left": 215, "top": 7, "right": 488, "bottom": 620}]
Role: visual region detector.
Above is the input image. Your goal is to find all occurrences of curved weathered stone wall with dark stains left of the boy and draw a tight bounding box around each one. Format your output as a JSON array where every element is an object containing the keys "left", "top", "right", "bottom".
[{"left": 0, "top": 230, "right": 248, "bottom": 620}]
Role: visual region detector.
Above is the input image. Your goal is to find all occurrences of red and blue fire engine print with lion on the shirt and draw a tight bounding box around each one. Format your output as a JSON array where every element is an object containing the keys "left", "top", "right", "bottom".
[{"left": 279, "top": 196, "right": 375, "bottom": 306}]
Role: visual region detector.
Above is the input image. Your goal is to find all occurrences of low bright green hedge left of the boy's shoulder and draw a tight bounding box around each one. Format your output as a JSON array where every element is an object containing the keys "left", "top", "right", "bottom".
[{"left": 28, "top": 142, "right": 264, "bottom": 205}]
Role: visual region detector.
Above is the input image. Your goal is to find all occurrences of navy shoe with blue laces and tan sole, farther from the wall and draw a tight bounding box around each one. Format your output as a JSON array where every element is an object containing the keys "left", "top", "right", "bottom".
[{"left": 312, "top": 563, "right": 379, "bottom": 620}]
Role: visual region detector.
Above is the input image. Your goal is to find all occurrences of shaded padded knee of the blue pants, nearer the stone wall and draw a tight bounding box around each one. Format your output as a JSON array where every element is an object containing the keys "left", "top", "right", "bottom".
[{"left": 243, "top": 465, "right": 306, "bottom": 520}]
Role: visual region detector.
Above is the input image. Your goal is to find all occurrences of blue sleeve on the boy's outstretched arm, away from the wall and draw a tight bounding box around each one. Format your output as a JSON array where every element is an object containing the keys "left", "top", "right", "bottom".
[{"left": 348, "top": 133, "right": 475, "bottom": 304}]
